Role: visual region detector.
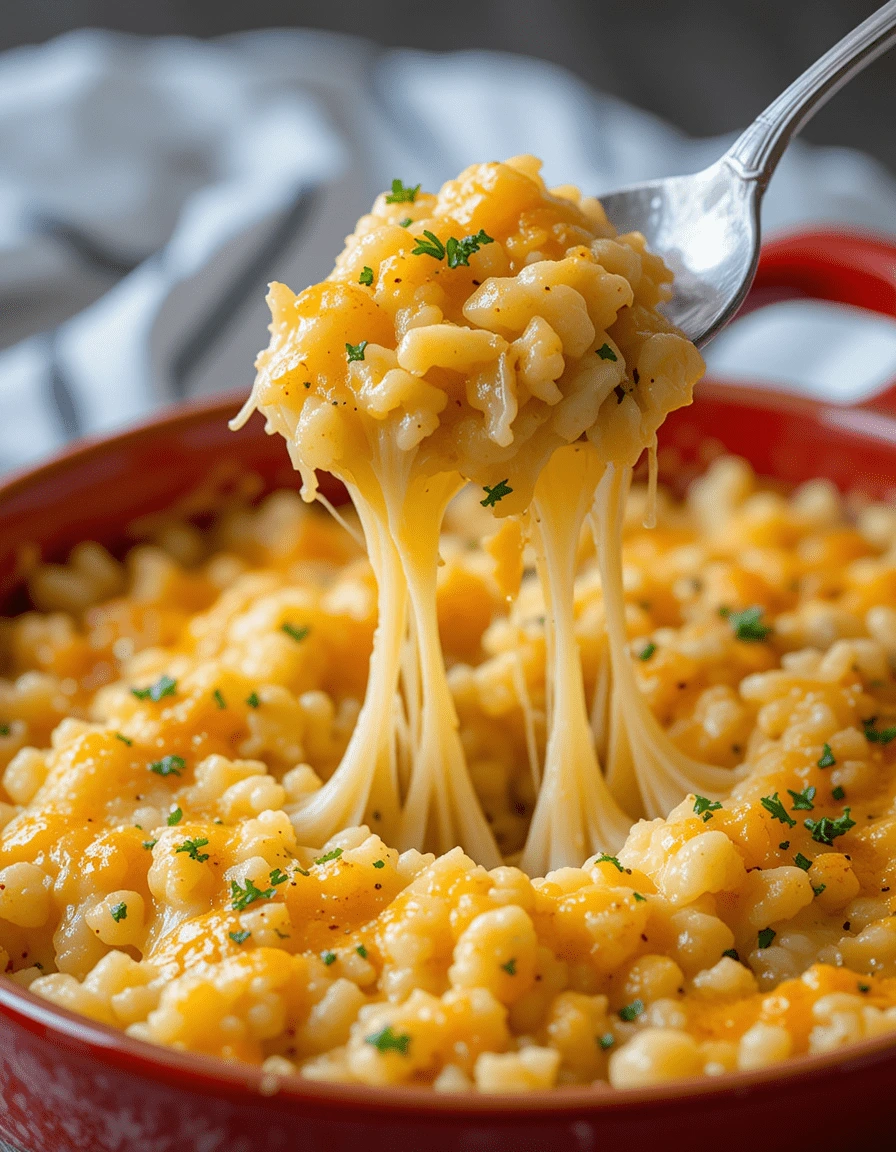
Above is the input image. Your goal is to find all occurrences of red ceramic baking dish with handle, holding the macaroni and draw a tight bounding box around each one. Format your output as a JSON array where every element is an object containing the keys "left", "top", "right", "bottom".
[{"left": 0, "top": 232, "right": 896, "bottom": 1152}]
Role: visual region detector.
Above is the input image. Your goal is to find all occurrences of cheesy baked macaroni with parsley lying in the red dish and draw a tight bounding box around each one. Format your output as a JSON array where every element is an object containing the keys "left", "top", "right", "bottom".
[{"left": 0, "top": 458, "right": 896, "bottom": 1092}]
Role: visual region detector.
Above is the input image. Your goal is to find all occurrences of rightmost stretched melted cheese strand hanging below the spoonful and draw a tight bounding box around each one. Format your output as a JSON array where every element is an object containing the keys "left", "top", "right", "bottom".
[{"left": 593, "top": 464, "right": 736, "bottom": 817}]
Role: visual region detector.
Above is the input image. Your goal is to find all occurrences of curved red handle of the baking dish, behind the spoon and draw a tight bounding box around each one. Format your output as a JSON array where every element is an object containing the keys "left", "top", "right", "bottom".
[{"left": 742, "top": 228, "right": 896, "bottom": 414}]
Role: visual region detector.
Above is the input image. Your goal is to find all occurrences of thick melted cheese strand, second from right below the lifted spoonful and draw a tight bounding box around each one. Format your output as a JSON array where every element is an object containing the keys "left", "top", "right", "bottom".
[{"left": 521, "top": 441, "right": 631, "bottom": 876}]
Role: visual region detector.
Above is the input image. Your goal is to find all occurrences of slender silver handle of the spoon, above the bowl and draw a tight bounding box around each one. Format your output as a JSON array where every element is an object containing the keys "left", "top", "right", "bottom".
[{"left": 726, "top": 0, "right": 896, "bottom": 189}]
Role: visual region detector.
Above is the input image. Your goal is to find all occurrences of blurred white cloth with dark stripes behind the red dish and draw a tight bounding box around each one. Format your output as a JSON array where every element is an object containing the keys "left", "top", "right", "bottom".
[{"left": 0, "top": 31, "right": 896, "bottom": 470}]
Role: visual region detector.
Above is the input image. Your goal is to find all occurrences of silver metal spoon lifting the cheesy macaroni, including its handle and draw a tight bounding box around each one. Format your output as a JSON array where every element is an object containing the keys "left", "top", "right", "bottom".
[{"left": 601, "top": 0, "right": 896, "bottom": 347}]
